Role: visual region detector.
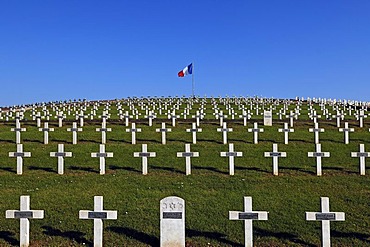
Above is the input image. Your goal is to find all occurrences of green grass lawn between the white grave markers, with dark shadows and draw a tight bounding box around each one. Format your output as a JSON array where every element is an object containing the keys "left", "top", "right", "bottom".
[{"left": 0, "top": 99, "right": 370, "bottom": 246}]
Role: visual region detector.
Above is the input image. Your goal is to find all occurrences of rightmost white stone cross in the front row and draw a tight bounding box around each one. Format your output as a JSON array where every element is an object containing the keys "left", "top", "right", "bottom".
[{"left": 306, "top": 197, "right": 345, "bottom": 247}]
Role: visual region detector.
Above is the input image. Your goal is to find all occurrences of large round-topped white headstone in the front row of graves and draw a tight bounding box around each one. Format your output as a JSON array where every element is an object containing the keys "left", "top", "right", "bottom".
[{"left": 160, "top": 196, "right": 185, "bottom": 247}]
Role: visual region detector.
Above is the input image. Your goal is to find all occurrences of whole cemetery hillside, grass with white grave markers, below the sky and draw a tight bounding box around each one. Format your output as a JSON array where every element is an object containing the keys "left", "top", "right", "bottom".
[{"left": 0, "top": 97, "right": 370, "bottom": 246}]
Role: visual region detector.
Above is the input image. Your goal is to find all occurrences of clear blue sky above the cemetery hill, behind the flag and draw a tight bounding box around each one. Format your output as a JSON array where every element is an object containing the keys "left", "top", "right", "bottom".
[{"left": 0, "top": 0, "right": 370, "bottom": 106}]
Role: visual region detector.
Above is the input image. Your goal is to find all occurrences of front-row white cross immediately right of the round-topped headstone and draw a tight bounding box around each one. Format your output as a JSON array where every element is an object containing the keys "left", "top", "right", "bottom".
[{"left": 229, "top": 196, "right": 269, "bottom": 247}]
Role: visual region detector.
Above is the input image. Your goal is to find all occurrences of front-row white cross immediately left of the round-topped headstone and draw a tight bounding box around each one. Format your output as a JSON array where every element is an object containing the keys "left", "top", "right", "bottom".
[{"left": 79, "top": 196, "right": 117, "bottom": 247}]
